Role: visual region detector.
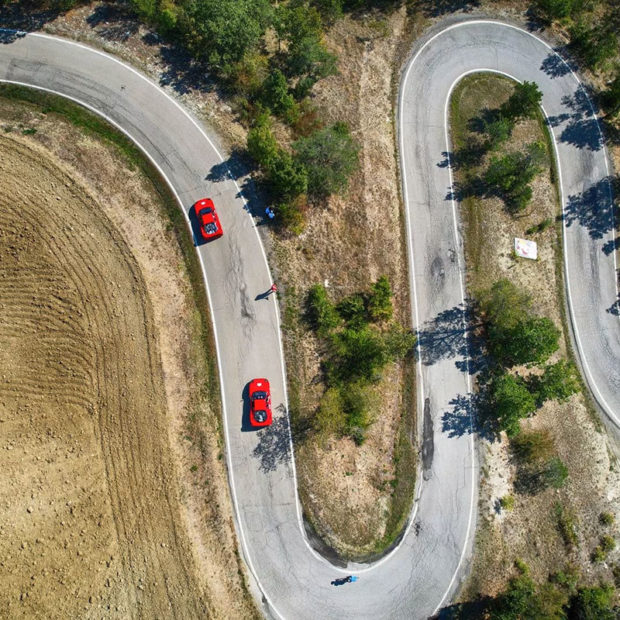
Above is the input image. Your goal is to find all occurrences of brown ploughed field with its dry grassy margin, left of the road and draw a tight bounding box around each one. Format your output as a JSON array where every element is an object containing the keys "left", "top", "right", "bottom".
[{"left": 0, "top": 98, "right": 256, "bottom": 618}]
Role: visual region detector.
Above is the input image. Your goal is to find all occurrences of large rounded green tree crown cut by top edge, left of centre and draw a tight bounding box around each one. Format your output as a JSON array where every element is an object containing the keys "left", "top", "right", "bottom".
[{"left": 179, "top": 0, "right": 271, "bottom": 73}]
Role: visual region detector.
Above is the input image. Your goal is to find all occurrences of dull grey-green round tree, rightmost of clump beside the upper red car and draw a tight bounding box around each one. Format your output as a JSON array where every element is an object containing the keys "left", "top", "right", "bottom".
[{"left": 293, "top": 123, "right": 359, "bottom": 198}]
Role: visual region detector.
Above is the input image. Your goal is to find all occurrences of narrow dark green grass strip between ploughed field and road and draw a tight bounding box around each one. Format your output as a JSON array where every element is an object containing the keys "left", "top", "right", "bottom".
[{"left": 0, "top": 84, "right": 221, "bottom": 410}]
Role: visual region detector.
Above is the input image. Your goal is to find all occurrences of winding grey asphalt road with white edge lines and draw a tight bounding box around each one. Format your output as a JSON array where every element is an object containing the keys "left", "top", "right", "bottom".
[{"left": 0, "top": 21, "right": 620, "bottom": 620}]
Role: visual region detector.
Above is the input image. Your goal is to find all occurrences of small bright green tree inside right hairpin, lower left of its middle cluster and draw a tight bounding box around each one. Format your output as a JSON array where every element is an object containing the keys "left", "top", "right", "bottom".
[{"left": 489, "top": 374, "right": 536, "bottom": 437}]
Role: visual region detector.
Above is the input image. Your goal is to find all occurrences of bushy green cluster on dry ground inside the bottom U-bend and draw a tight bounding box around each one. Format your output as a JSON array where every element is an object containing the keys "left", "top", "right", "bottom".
[{"left": 306, "top": 276, "right": 415, "bottom": 444}]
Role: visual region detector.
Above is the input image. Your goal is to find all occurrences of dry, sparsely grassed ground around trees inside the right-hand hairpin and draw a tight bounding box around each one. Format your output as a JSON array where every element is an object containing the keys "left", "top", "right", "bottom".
[{"left": 451, "top": 74, "right": 620, "bottom": 600}]
